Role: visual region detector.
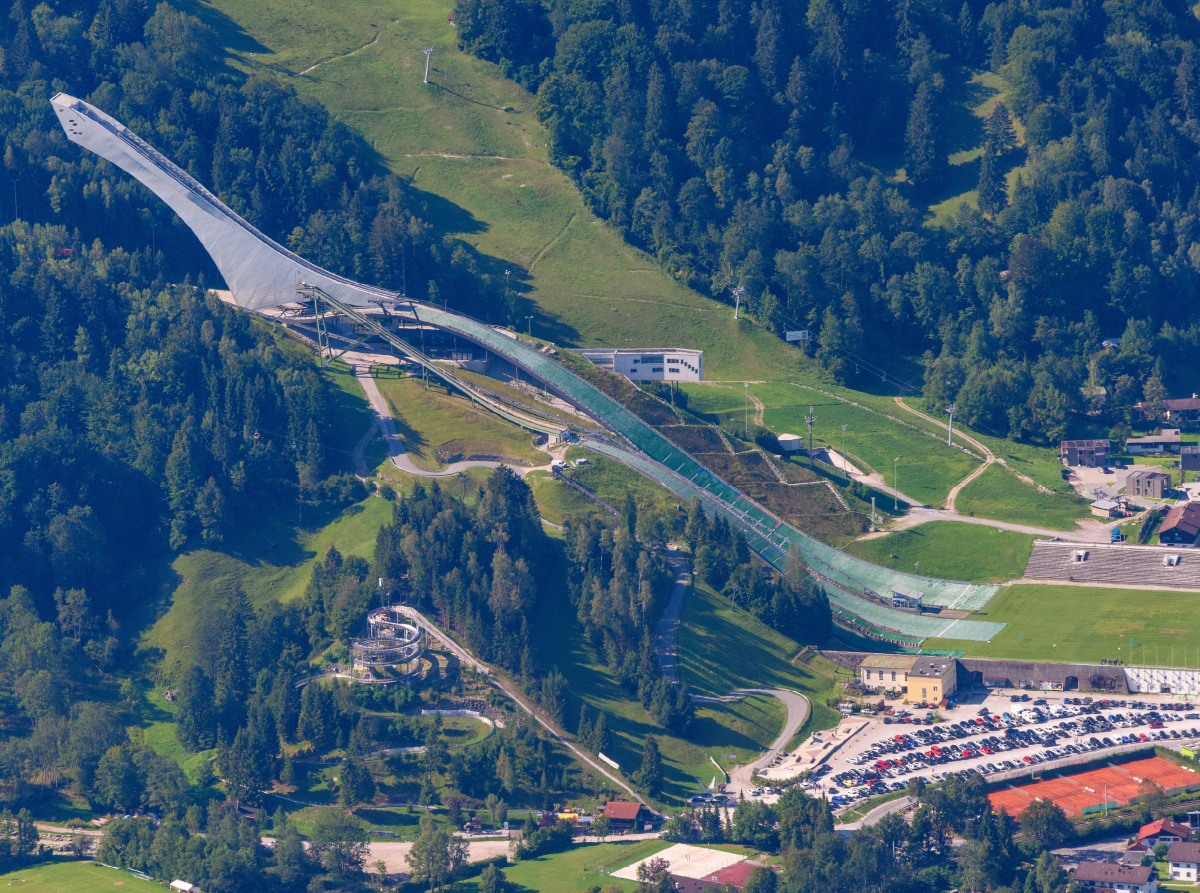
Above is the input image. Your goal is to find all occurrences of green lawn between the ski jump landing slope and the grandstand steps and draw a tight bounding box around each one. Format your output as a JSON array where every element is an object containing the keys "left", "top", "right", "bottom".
[{"left": 845, "top": 521, "right": 1037, "bottom": 583}]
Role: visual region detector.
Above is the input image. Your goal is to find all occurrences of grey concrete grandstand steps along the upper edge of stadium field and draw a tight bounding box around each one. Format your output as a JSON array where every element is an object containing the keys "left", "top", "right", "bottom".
[{"left": 1025, "top": 540, "right": 1200, "bottom": 589}]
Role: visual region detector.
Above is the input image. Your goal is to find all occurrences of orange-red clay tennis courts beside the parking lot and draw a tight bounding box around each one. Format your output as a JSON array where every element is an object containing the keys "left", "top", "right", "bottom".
[{"left": 988, "top": 756, "right": 1200, "bottom": 816}]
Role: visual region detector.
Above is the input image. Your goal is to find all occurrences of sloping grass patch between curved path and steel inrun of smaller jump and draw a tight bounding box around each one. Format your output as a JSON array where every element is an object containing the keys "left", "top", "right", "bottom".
[{"left": 378, "top": 378, "right": 550, "bottom": 471}]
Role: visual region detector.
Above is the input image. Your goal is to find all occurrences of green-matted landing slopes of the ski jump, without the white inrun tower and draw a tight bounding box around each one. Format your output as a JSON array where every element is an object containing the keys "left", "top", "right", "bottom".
[{"left": 416, "top": 306, "right": 1004, "bottom": 641}]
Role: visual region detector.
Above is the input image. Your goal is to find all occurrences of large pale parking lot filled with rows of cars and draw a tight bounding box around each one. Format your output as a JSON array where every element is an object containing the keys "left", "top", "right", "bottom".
[{"left": 803, "top": 691, "right": 1200, "bottom": 808}]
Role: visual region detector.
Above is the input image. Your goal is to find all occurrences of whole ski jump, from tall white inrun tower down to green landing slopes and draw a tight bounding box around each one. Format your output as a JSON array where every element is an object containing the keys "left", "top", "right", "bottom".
[{"left": 50, "top": 94, "right": 1004, "bottom": 641}]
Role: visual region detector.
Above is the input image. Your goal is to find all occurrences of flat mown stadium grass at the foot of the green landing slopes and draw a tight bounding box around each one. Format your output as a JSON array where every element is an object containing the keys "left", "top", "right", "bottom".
[{"left": 925, "top": 585, "right": 1200, "bottom": 667}]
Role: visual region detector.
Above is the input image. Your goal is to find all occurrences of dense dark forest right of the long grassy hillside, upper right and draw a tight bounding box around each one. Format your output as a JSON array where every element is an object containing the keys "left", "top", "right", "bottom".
[{"left": 455, "top": 0, "right": 1200, "bottom": 443}]
